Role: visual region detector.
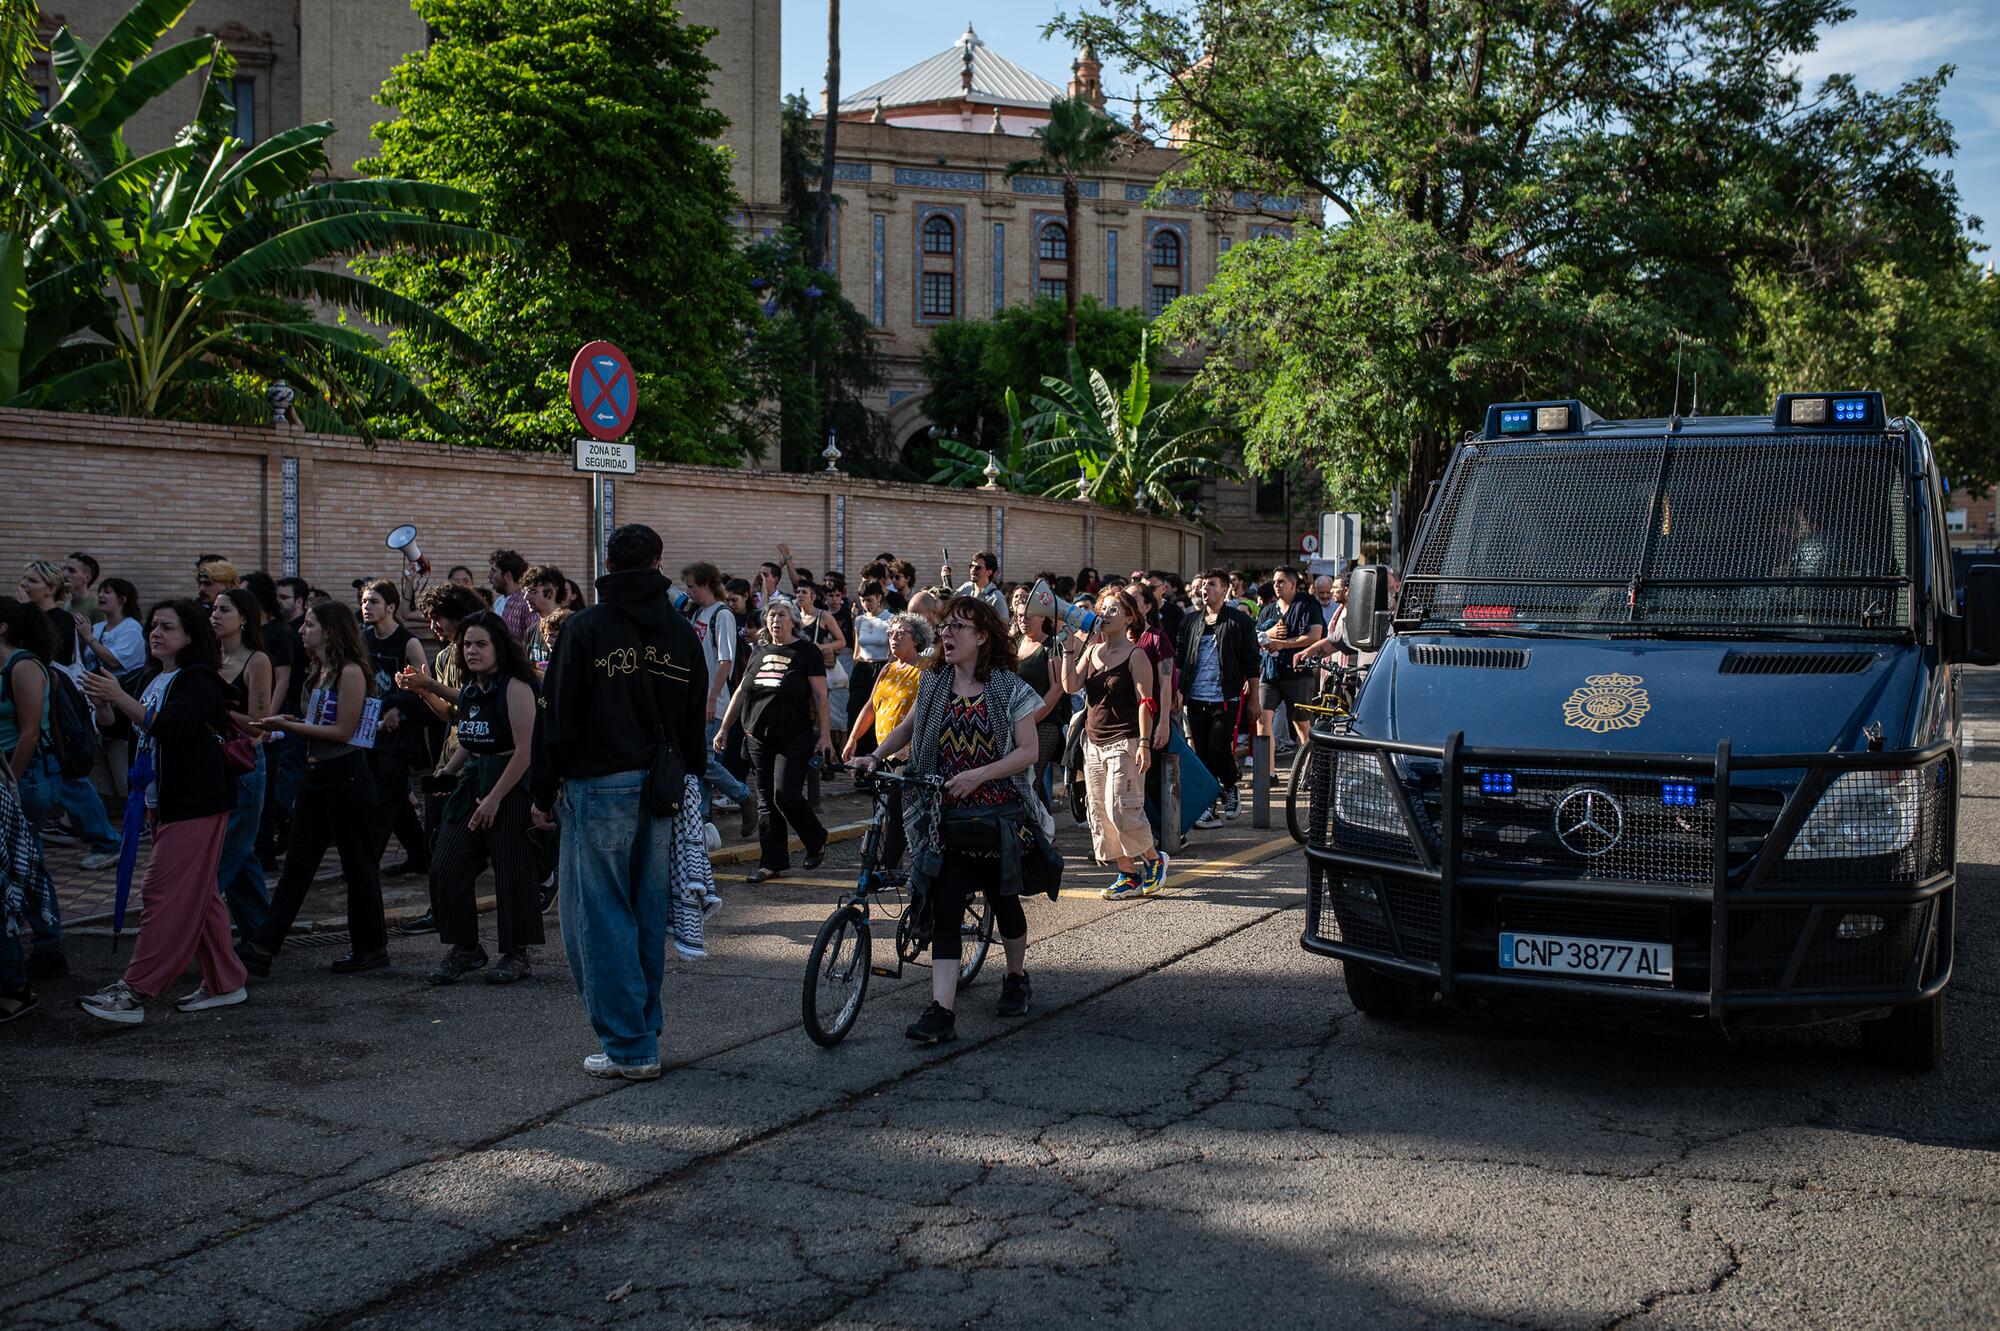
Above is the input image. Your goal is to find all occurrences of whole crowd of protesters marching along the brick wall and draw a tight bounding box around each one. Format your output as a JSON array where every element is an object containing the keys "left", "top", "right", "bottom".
[{"left": 0, "top": 526, "right": 1346, "bottom": 1077}]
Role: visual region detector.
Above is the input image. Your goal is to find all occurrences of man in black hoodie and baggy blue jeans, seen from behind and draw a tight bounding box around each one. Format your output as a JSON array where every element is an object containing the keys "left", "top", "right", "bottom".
[{"left": 528, "top": 524, "right": 708, "bottom": 1081}]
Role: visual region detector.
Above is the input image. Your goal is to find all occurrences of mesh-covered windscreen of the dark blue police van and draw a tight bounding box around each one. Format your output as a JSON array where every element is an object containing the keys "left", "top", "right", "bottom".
[{"left": 1396, "top": 425, "right": 1912, "bottom": 638}]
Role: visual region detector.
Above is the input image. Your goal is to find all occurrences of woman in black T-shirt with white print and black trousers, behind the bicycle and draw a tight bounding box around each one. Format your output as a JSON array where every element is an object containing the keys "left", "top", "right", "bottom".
[{"left": 714, "top": 596, "right": 834, "bottom": 883}]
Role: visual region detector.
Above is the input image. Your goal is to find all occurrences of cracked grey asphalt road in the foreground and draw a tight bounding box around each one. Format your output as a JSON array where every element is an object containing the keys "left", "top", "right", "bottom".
[{"left": 0, "top": 671, "right": 2000, "bottom": 1331}]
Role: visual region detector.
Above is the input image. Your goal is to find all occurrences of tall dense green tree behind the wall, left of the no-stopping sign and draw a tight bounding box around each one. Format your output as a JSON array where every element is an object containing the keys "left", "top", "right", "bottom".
[{"left": 362, "top": 0, "right": 756, "bottom": 464}]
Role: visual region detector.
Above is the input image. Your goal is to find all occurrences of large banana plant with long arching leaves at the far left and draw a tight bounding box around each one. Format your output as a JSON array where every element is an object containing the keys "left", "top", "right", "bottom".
[{"left": 0, "top": 0, "right": 506, "bottom": 421}]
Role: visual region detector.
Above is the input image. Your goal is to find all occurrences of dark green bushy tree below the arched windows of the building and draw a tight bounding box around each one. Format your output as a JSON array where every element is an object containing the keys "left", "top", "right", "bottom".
[{"left": 918, "top": 296, "right": 1158, "bottom": 451}]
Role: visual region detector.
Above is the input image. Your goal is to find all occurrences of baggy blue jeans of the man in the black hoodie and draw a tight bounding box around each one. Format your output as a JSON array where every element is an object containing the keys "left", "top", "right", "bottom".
[{"left": 560, "top": 771, "right": 674, "bottom": 1065}]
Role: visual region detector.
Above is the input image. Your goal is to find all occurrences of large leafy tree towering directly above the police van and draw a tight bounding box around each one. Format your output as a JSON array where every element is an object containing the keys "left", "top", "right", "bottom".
[{"left": 1056, "top": 0, "right": 1964, "bottom": 539}]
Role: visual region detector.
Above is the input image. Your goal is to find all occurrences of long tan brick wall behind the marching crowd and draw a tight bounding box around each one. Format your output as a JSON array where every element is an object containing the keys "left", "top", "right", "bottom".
[{"left": 0, "top": 410, "right": 1202, "bottom": 602}]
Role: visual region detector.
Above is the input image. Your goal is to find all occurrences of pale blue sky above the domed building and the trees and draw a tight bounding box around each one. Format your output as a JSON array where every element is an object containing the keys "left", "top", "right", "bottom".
[{"left": 782, "top": 0, "right": 2000, "bottom": 242}]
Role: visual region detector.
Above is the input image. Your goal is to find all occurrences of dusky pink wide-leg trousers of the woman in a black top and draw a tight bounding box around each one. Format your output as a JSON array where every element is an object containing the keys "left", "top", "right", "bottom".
[{"left": 126, "top": 813, "right": 246, "bottom": 997}]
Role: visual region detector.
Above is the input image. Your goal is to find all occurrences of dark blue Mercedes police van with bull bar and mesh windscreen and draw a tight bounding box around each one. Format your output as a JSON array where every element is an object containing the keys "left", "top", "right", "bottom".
[{"left": 1302, "top": 392, "right": 2000, "bottom": 1069}]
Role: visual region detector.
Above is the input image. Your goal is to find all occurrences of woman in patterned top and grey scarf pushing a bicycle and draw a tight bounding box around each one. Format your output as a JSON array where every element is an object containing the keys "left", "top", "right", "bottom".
[{"left": 856, "top": 596, "right": 1054, "bottom": 1045}]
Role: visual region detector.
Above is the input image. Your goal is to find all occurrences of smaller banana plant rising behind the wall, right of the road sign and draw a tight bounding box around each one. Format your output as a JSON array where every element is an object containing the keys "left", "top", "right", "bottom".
[{"left": 1028, "top": 328, "right": 1240, "bottom": 518}]
